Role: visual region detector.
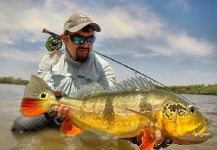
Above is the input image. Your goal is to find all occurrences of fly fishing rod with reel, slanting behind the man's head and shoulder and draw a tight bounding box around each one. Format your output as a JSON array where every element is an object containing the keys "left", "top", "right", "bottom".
[{"left": 42, "top": 28, "right": 183, "bottom": 97}]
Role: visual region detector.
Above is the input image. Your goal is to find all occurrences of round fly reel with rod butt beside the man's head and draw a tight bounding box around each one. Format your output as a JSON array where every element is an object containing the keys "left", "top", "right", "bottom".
[{"left": 42, "top": 29, "right": 63, "bottom": 52}]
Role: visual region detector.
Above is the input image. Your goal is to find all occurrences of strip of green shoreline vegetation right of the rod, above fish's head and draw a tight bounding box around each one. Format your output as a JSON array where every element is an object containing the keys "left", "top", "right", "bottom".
[{"left": 169, "top": 84, "right": 217, "bottom": 95}]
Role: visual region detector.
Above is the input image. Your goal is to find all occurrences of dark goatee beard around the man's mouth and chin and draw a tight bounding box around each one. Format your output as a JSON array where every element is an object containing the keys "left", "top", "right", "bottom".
[{"left": 76, "top": 47, "right": 90, "bottom": 62}]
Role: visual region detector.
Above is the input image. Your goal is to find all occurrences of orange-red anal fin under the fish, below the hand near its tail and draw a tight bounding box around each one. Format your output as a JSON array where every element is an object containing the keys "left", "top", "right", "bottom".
[{"left": 60, "top": 117, "right": 82, "bottom": 136}]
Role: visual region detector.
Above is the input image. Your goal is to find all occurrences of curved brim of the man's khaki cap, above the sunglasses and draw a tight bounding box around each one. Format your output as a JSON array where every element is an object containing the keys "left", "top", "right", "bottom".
[{"left": 67, "top": 22, "right": 101, "bottom": 32}]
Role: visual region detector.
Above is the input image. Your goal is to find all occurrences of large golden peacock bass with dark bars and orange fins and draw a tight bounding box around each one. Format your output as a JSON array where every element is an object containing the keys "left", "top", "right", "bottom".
[{"left": 21, "top": 75, "right": 212, "bottom": 150}]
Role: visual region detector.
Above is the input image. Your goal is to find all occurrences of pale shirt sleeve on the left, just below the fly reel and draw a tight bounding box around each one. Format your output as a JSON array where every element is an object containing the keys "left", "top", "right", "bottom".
[{"left": 38, "top": 54, "right": 57, "bottom": 89}]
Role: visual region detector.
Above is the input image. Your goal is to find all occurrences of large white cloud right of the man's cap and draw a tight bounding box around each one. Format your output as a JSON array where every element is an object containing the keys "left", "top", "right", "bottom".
[{"left": 96, "top": 6, "right": 216, "bottom": 57}]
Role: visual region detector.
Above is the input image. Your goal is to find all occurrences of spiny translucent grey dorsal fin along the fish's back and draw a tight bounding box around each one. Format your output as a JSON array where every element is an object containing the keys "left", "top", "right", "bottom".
[{"left": 71, "top": 76, "right": 154, "bottom": 98}]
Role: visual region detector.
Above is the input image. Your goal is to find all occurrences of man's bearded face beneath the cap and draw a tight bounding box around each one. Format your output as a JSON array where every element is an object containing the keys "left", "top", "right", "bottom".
[{"left": 66, "top": 28, "right": 94, "bottom": 62}]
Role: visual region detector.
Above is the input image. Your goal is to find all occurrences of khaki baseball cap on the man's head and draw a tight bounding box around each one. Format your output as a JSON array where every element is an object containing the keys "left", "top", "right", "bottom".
[{"left": 63, "top": 13, "right": 101, "bottom": 32}]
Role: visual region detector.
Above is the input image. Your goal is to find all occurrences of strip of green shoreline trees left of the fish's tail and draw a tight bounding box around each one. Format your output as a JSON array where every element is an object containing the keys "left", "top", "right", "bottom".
[{"left": 0, "top": 77, "right": 28, "bottom": 85}]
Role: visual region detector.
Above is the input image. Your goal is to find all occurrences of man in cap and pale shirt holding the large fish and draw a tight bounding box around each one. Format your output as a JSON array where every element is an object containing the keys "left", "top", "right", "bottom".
[{"left": 12, "top": 14, "right": 171, "bottom": 149}]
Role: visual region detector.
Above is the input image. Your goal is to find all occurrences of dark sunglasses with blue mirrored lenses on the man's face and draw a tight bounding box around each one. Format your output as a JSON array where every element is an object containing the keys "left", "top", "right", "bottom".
[{"left": 69, "top": 35, "right": 96, "bottom": 45}]
